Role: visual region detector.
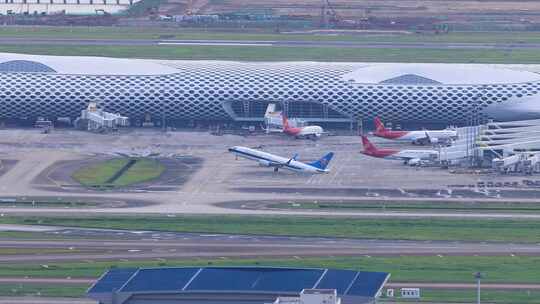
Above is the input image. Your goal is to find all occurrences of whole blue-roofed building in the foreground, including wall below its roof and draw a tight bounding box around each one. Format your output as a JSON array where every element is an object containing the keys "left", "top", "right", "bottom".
[{"left": 88, "top": 267, "right": 390, "bottom": 304}]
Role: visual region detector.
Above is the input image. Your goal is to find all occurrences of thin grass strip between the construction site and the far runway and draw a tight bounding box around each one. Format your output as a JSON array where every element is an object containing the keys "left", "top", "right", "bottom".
[{"left": 0, "top": 26, "right": 540, "bottom": 43}]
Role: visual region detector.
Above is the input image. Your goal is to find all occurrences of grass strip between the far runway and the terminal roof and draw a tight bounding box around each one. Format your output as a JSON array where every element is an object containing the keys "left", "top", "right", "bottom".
[{"left": 0, "top": 45, "right": 540, "bottom": 64}]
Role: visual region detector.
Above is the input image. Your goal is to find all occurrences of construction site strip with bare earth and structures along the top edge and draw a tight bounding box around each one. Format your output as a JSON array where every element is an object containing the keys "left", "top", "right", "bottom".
[{"left": 0, "top": 0, "right": 540, "bottom": 33}]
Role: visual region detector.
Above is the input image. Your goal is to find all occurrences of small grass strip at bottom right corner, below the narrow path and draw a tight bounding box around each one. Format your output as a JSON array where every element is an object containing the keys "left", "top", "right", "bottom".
[{"left": 386, "top": 289, "right": 540, "bottom": 304}]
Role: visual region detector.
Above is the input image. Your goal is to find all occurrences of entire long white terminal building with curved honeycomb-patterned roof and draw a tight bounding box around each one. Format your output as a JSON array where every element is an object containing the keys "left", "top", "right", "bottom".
[{"left": 0, "top": 53, "right": 540, "bottom": 123}]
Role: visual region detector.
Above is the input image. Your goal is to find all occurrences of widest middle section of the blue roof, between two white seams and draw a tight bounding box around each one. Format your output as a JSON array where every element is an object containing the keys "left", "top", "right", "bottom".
[{"left": 186, "top": 268, "right": 323, "bottom": 292}]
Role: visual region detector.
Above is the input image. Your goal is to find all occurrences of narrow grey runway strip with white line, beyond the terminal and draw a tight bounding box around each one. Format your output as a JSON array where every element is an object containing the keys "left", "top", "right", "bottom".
[{"left": 0, "top": 37, "right": 540, "bottom": 50}]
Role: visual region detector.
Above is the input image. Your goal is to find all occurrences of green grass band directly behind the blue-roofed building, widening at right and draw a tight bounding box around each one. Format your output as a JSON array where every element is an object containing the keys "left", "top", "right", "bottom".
[{"left": 0, "top": 256, "right": 540, "bottom": 283}]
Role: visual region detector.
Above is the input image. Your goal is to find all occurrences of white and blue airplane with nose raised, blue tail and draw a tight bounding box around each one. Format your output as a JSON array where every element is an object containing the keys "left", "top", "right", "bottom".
[{"left": 229, "top": 146, "right": 334, "bottom": 174}]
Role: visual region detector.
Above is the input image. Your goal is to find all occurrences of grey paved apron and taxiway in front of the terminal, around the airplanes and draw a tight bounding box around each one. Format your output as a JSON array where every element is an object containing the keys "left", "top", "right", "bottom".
[{"left": 0, "top": 129, "right": 540, "bottom": 219}]
